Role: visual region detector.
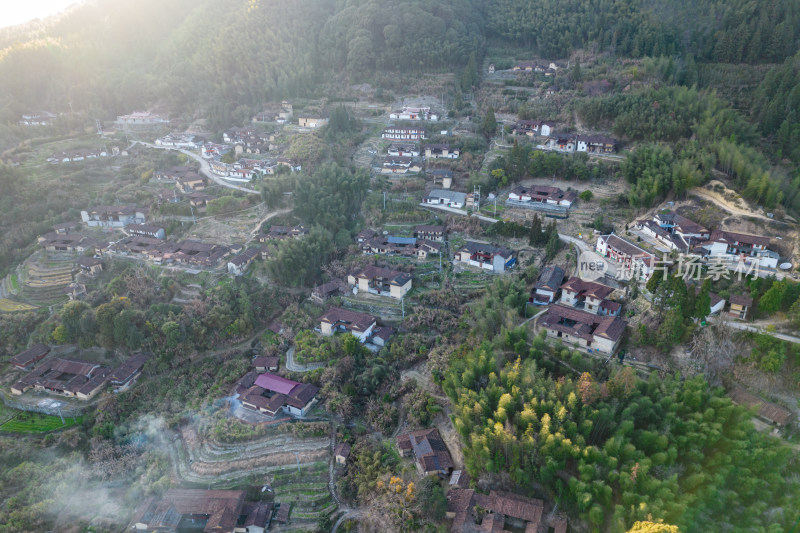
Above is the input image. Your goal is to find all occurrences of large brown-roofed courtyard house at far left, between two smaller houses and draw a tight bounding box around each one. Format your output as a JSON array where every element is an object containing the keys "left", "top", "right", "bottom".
[{"left": 11, "top": 357, "right": 111, "bottom": 400}]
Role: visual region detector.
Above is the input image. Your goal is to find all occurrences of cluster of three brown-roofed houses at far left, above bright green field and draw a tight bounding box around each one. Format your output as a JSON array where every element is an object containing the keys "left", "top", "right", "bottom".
[{"left": 9, "top": 350, "right": 150, "bottom": 400}]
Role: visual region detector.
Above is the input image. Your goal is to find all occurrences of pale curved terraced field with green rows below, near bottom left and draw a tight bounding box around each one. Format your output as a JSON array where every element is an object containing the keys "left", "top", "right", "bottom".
[{"left": 169, "top": 420, "right": 336, "bottom": 531}]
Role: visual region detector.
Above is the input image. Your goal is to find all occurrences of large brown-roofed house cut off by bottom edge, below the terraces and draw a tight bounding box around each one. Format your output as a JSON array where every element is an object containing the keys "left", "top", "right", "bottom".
[{"left": 128, "top": 489, "right": 272, "bottom": 533}]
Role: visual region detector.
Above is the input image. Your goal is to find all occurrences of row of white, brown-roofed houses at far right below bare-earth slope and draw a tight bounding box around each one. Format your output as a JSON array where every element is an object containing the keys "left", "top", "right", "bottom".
[{"left": 634, "top": 211, "right": 780, "bottom": 269}]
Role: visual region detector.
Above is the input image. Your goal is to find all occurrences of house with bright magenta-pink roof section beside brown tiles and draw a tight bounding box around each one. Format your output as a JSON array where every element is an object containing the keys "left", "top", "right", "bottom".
[{"left": 237, "top": 373, "right": 319, "bottom": 418}]
